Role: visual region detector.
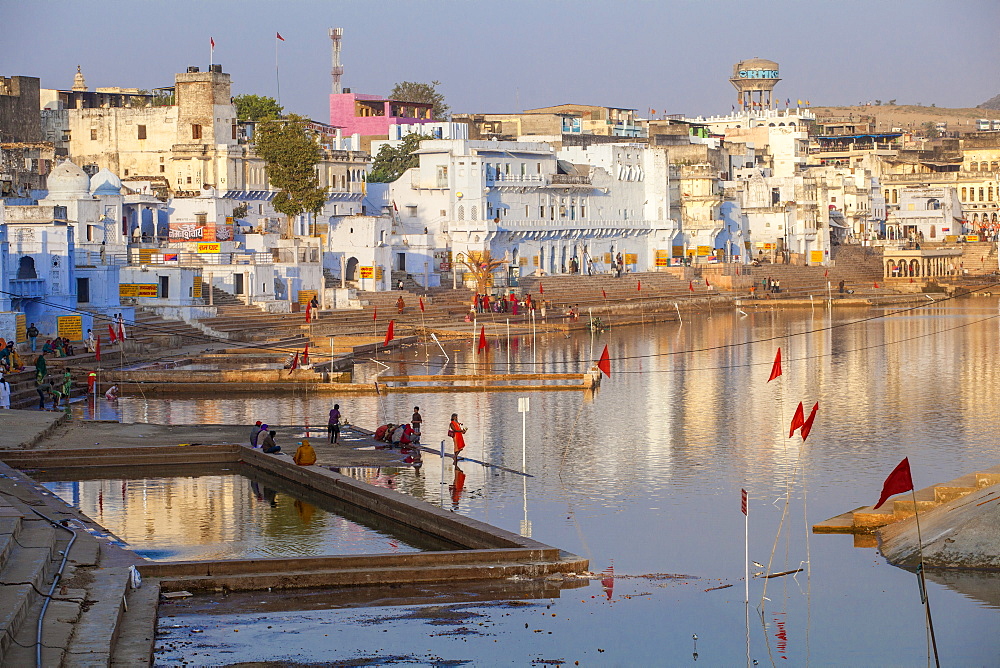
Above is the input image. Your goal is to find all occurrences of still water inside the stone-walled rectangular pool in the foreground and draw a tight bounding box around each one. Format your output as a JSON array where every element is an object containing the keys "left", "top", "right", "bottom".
[{"left": 44, "top": 474, "right": 428, "bottom": 561}]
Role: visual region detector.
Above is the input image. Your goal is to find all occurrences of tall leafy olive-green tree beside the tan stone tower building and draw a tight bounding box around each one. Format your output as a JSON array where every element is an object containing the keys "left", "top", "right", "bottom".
[{"left": 253, "top": 114, "right": 326, "bottom": 237}]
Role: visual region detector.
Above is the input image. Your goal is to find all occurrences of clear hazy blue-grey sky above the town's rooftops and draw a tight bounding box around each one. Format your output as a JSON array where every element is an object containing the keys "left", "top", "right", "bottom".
[{"left": 0, "top": 0, "right": 1000, "bottom": 121}]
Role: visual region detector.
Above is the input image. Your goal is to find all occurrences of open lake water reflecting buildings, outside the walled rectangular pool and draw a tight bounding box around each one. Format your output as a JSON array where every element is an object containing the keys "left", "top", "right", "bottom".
[{"left": 72, "top": 298, "right": 1000, "bottom": 666}]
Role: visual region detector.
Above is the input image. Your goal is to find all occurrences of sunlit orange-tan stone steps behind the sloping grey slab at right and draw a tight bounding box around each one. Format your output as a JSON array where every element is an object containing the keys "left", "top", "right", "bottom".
[{"left": 813, "top": 466, "right": 1000, "bottom": 534}]
